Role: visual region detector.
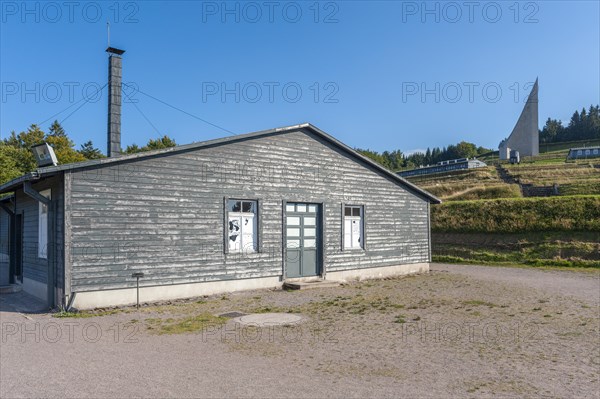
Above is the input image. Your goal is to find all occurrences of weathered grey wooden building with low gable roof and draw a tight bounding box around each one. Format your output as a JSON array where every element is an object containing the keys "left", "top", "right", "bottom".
[{"left": 0, "top": 124, "right": 439, "bottom": 309}]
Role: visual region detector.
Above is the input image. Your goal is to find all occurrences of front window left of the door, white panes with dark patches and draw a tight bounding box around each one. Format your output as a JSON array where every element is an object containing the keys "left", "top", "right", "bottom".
[{"left": 225, "top": 198, "right": 259, "bottom": 253}]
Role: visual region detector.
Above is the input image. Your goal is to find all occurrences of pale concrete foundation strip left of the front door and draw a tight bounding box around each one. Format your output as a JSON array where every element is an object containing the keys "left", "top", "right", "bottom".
[{"left": 73, "top": 277, "right": 282, "bottom": 310}]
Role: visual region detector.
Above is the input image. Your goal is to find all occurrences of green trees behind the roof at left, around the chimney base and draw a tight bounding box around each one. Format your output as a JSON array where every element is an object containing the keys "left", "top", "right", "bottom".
[{"left": 0, "top": 121, "right": 177, "bottom": 184}]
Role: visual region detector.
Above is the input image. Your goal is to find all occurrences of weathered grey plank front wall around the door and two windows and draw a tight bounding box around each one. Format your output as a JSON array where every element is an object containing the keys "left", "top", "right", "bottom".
[{"left": 65, "top": 130, "right": 429, "bottom": 292}]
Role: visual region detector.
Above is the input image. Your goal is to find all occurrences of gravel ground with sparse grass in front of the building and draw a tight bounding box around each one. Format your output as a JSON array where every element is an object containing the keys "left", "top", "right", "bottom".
[{"left": 0, "top": 265, "right": 600, "bottom": 398}]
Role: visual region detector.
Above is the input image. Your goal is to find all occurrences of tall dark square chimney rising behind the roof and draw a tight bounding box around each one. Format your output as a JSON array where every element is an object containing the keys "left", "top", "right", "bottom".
[{"left": 106, "top": 47, "right": 125, "bottom": 157}]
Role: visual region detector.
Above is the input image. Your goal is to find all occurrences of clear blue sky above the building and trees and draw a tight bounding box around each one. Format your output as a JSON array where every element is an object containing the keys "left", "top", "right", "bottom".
[{"left": 0, "top": 1, "right": 600, "bottom": 151}]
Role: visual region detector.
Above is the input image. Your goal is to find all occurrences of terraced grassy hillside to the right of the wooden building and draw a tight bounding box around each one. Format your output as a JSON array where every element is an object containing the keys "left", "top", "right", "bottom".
[{"left": 409, "top": 141, "right": 600, "bottom": 268}]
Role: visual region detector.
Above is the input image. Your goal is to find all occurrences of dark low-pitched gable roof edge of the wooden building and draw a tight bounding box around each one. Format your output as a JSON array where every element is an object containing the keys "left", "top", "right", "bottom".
[{"left": 0, "top": 123, "right": 442, "bottom": 204}]
